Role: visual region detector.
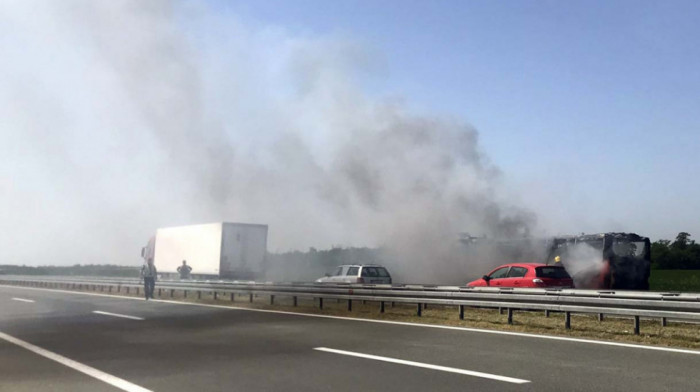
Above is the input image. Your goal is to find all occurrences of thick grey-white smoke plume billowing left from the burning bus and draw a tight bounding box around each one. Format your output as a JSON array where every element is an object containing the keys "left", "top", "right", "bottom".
[{"left": 0, "top": 1, "right": 534, "bottom": 281}]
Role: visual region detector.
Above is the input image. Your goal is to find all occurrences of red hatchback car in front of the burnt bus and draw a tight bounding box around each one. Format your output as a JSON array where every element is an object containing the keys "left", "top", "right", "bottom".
[{"left": 467, "top": 263, "right": 574, "bottom": 288}]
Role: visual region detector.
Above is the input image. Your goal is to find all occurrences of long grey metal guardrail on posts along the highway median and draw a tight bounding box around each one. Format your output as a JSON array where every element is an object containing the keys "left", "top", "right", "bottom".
[{"left": 0, "top": 276, "right": 700, "bottom": 334}]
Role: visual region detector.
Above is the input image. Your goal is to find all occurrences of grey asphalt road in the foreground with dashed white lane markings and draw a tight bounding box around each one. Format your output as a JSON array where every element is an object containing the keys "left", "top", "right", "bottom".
[{"left": 0, "top": 286, "right": 700, "bottom": 392}]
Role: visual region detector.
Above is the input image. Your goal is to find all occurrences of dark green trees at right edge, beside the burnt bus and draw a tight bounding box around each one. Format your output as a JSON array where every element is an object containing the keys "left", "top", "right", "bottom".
[{"left": 651, "top": 232, "right": 700, "bottom": 269}]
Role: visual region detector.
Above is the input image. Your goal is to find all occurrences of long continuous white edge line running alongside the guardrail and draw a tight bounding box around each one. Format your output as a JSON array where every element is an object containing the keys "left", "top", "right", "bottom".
[{"left": 0, "top": 284, "right": 700, "bottom": 355}]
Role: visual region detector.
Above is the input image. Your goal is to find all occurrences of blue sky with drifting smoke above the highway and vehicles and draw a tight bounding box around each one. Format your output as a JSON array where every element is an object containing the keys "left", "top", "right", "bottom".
[{"left": 0, "top": 0, "right": 700, "bottom": 265}]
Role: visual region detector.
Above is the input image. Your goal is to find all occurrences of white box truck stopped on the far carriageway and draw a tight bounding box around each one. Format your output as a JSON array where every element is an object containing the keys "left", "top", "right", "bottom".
[{"left": 141, "top": 222, "right": 267, "bottom": 279}]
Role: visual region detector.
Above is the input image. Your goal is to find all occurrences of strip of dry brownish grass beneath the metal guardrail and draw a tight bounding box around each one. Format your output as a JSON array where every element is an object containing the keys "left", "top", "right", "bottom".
[{"left": 76, "top": 288, "right": 700, "bottom": 349}]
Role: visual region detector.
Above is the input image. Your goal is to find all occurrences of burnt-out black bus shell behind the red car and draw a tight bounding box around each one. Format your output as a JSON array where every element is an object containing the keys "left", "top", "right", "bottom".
[{"left": 545, "top": 233, "right": 651, "bottom": 290}]
